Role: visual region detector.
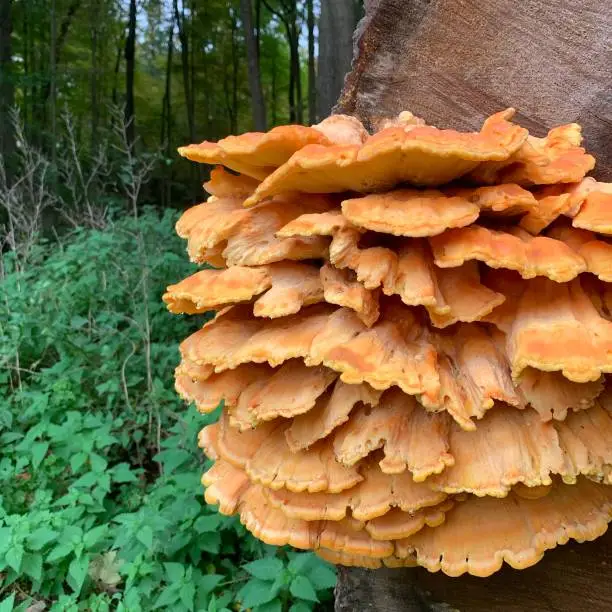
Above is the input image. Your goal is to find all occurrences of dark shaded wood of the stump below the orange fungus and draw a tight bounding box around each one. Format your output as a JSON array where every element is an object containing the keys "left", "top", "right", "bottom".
[{"left": 335, "top": 532, "right": 612, "bottom": 612}]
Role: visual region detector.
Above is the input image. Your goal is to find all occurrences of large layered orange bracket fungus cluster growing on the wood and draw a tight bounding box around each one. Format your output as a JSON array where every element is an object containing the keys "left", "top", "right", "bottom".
[{"left": 164, "top": 109, "right": 612, "bottom": 576}]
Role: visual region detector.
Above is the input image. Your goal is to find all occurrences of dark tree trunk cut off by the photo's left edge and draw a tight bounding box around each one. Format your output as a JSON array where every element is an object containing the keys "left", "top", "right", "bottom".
[{"left": 0, "top": 0, "right": 15, "bottom": 169}]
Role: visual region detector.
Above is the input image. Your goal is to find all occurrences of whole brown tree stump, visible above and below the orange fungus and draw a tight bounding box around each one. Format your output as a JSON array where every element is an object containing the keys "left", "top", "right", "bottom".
[{"left": 335, "top": 0, "right": 612, "bottom": 612}]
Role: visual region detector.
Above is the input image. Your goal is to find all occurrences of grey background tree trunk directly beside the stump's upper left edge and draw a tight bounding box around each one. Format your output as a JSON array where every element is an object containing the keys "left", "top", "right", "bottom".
[{"left": 317, "top": 0, "right": 354, "bottom": 119}]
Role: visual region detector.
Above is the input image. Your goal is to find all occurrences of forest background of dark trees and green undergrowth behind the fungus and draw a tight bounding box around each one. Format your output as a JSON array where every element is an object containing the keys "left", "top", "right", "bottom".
[{"left": 0, "top": 0, "right": 363, "bottom": 612}]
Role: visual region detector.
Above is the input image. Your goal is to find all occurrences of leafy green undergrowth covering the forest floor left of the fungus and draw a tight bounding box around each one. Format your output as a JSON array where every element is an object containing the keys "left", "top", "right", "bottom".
[{"left": 0, "top": 211, "right": 335, "bottom": 612}]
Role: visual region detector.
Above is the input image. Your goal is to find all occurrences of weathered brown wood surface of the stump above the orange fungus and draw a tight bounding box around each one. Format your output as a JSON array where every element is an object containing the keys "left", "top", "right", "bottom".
[{"left": 338, "top": 0, "right": 612, "bottom": 180}]
